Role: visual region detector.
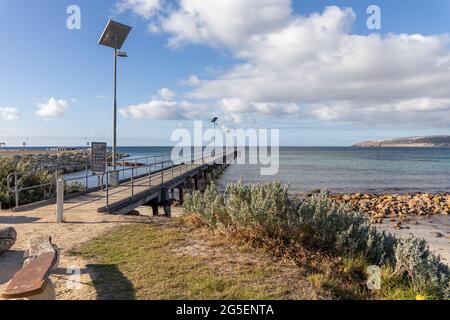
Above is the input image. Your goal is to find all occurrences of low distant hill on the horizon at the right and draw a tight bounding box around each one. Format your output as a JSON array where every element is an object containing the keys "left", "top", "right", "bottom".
[{"left": 354, "top": 136, "right": 450, "bottom": 148}]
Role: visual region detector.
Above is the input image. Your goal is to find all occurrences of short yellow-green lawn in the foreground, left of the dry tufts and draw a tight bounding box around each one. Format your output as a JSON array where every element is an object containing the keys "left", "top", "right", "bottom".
[{"left": 72, "top": 219, "right": 323, "bottom": 300}]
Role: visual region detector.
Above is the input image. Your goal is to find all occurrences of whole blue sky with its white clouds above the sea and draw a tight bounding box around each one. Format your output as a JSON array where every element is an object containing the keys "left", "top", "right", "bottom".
[{"left": 0, "top": 0, "right": 450, "bottom": 146}]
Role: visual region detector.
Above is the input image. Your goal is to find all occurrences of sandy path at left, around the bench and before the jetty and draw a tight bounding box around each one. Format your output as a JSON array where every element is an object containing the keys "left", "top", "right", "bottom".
[{"left": 0, "top": 208, "right": 180, "bottom": 300}]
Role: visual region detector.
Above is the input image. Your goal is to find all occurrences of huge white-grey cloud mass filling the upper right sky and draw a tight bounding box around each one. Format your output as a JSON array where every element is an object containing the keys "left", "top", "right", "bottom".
[{"left": 120, "top": 0, "right": 450, "bottom": 126}]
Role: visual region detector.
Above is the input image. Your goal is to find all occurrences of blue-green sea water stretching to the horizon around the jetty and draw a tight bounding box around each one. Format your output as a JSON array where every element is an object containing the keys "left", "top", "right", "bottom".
[{"left": 3, "top": 147, "right": 450, "bottom": 193}]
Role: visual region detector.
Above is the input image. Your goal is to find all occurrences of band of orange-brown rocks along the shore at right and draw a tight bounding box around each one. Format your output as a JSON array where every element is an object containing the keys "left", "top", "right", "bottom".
[{"left": 330, "top": 193, "right": 450, "bottom": 227}]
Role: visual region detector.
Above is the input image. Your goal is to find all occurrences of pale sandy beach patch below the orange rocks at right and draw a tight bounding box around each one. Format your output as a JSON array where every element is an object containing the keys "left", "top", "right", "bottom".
[{"left": 376, "top": 215, "right": 450, "bottom": 266}]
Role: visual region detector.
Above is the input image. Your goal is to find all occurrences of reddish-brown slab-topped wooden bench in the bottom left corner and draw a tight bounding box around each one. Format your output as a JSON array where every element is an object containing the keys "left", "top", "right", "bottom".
[{"left": 2, "top": 236, "right": 59, "bottom": 299}]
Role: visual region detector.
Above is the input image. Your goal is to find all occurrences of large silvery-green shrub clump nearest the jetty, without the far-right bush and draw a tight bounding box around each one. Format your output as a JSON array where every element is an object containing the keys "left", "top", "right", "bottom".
[{"left": 185, "top": 181, "right": 395, "bottom": 264}]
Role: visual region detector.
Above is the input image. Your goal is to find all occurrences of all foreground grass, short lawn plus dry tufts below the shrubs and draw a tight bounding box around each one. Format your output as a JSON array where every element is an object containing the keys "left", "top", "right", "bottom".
[{"left": 71, "top": 215, "right": 422, "bottom": 300}]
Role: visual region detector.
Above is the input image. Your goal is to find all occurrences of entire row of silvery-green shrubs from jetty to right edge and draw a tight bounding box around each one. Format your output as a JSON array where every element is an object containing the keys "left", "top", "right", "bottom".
[{"left": 185, "top": 181, "right": 450, "bottom": 298}]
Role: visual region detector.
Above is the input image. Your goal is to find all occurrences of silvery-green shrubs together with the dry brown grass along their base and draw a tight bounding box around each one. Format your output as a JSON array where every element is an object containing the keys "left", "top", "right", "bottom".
[{"left": 184, "top": 181, "right": 450, "bottom": 299}]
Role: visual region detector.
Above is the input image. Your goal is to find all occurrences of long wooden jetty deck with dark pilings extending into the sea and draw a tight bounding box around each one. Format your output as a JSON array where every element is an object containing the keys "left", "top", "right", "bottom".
[{"left": 14, "top": 151, "right": 237, "bottom": 216}]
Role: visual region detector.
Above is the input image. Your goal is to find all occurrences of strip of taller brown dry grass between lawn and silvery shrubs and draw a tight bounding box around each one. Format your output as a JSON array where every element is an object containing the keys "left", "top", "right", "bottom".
[{"left": 181, "top": 215, "right": 424, "bottom": 300}]
